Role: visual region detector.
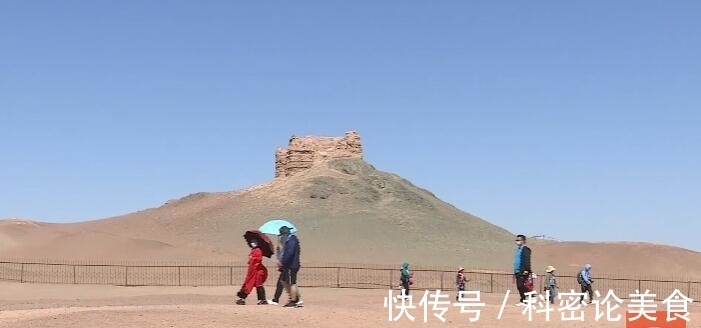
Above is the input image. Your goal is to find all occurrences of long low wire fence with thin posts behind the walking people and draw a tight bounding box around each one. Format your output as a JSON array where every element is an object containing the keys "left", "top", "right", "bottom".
[{"left": 0, "top": 261, "right": 701, "bottom": 300}]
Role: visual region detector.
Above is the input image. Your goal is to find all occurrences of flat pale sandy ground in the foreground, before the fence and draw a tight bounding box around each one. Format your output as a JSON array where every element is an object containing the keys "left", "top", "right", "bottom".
[{"left": 0, "top": 283, "right": 701, "bottom": 328}]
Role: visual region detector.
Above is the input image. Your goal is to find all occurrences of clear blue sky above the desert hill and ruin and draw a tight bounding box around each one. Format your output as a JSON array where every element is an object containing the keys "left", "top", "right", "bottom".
[{"left": 0, "top": 0, "right": 701, "bottom": 250}]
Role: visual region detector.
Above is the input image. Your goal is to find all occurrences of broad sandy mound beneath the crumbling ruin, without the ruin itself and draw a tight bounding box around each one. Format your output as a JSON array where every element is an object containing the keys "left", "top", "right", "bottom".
[{"left": 0, "top": 159, "right": 513, "bottom": 268}]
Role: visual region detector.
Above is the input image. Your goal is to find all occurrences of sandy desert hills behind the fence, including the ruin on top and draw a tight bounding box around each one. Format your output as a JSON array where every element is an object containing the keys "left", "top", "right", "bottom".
[{"left": 0, "top": 132, "right": 701, "bottom": 276}]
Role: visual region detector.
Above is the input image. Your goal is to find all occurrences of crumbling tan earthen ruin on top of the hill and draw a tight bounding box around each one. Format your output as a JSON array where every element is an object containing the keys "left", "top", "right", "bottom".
[{"left": 275, "top": 131, "right": 363, "bottom": 178}]
